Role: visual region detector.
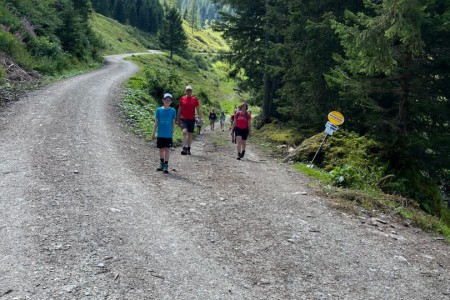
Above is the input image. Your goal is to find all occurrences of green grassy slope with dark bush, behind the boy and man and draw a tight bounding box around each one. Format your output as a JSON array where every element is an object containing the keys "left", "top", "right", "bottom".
[{"left": 121, "top": 54, "right": 246, "bottom": 144}]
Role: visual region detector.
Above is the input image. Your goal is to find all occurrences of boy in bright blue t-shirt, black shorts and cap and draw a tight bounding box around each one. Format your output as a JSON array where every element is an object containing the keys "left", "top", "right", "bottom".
[{"left": 152, "top": 93, "right": 177, "bottom": 174}]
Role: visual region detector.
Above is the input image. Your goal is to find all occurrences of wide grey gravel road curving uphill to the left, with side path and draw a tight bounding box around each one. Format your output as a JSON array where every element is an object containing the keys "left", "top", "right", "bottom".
[{"left": 0, "top": 52, "right": 450, "bottom": 300}]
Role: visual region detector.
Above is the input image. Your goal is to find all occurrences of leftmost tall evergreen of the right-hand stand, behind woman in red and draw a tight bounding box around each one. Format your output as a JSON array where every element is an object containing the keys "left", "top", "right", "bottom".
[{"left": 214, "top": 0, "right": 278, "bottom": 124}]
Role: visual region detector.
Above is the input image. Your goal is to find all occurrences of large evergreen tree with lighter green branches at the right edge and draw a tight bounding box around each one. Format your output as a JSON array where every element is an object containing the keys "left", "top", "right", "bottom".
[{"left": 328, "top": 0, "right": 450, "bottom": 214}]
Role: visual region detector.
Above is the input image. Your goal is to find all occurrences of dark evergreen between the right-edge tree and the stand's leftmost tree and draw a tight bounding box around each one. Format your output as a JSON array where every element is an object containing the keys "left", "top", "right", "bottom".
[{"left": 273, "top": 0, "right": 363, "bottom": 130}]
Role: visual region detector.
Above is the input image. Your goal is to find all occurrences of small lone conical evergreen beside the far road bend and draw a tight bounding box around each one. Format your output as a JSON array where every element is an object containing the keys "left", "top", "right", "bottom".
[{"left": 159, "top": 7, "right": 187, "bottom": 58}]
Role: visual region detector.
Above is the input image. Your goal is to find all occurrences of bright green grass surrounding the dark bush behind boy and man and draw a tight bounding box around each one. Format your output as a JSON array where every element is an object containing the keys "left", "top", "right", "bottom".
[{"left": 121, "top": 54, "right": 242, "bottom": 145}]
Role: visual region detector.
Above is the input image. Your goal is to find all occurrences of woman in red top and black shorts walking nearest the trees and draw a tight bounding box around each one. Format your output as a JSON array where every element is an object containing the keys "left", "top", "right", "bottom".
[{"left": 233, "top": 103, "right": 252, "bottom": 160}]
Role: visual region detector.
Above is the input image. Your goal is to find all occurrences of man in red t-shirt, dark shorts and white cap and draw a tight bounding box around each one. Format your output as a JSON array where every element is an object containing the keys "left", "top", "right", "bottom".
[{"left": 177, "top": 85, "right": 202, "bottom": 155}]
